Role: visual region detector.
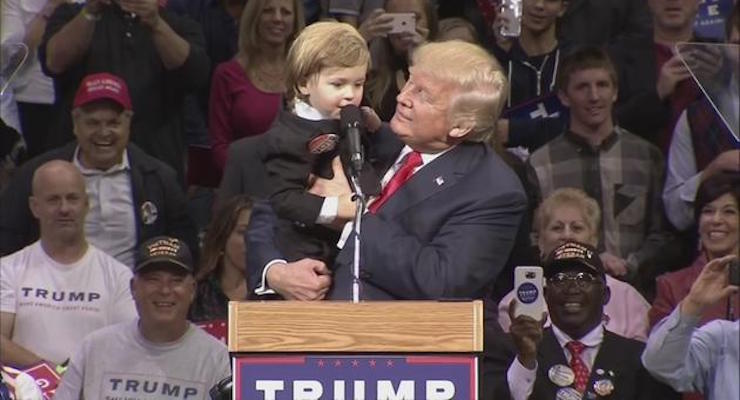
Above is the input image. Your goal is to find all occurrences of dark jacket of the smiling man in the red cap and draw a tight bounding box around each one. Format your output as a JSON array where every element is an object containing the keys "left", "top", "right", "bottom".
[{"left": 0, "top": 142, "right": 198, "bottom": 260}]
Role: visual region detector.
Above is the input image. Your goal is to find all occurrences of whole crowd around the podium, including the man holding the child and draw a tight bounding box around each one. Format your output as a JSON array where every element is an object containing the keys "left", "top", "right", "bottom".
[{"left": 0, "top": 0, "right": 740, "bottom": 400}]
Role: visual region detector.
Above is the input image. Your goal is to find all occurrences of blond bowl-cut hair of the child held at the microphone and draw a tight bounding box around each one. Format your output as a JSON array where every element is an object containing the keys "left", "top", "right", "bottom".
[{"left": 286, "top": 21, "right": 370, "bottom": 100}]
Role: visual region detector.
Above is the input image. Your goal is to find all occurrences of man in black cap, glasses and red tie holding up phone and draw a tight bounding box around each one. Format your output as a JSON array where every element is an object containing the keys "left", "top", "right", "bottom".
[{"left": 483, "top": 242, "right": 676, "bottom": 400}]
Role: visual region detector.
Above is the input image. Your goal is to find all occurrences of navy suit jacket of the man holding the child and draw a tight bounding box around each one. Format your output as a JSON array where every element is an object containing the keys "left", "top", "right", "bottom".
[{"left": 247, "top": 130, "right": 527, "bottom": 300}]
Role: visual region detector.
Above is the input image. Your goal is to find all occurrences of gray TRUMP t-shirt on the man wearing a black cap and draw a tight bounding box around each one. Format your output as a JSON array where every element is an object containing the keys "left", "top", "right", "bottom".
[{"left": 54, "top": 319, "right": 231, "bottom": 400}]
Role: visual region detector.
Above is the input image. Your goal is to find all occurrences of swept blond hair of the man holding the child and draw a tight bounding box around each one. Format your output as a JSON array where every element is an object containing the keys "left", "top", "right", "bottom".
[{"left": 411, "top": 40, "right": 508, "bottom": 142}]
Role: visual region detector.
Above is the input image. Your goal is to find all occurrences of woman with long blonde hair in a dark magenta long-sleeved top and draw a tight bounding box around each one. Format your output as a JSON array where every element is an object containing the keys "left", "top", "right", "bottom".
[{"left": 208, "top": 0, "right": 304, "bottom": 177}]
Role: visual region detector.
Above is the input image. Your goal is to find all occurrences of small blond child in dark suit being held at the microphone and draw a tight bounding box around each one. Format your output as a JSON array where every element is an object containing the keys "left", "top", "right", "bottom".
[{"left": 264, "top": 22, "right": 380, "bottom": 265}]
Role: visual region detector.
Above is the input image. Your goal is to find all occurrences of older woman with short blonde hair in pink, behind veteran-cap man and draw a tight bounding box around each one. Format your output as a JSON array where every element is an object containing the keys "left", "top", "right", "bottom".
[{"left": 498, "top": 188, "right": 650, "bottom": 341}]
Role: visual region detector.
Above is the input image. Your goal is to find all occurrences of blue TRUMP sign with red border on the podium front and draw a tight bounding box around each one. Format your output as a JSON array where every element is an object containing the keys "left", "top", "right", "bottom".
[{"left": 234, "top": 355, "right": 478, "bottom": 400}]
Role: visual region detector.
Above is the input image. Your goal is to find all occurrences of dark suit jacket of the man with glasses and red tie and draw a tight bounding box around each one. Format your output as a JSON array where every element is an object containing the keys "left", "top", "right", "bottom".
[{"left": 480, "top": 328, "right": 679, "bottom": 400}]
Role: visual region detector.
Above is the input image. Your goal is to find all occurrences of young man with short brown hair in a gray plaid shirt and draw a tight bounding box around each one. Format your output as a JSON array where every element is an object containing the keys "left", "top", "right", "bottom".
[{"left": 529, "top": 48, "right": 670, "bottom": 280}]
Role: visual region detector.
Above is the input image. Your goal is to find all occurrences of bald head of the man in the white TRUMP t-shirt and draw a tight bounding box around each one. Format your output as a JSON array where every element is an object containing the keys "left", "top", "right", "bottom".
[{"left": 29, "top": 160, "right": 88, "bottom": 242}]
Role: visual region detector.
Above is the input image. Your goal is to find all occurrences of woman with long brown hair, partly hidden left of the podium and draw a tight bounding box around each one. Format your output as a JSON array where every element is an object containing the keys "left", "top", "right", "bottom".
[{"left": 189, "top": 196, "right": 252, "bottom": 322}]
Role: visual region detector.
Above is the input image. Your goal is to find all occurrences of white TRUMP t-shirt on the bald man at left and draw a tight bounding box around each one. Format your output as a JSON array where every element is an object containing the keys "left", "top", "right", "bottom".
[{"left": 0, "top": 241, "right": 137, "bottom": 364}]
